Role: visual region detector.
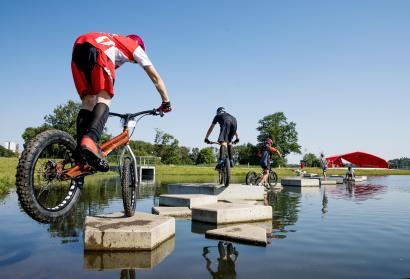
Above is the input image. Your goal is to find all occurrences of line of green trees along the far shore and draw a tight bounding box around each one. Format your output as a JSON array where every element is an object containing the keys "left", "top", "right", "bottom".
[{"left": 22, "top": 101, "right": 301, "bottom": 166}]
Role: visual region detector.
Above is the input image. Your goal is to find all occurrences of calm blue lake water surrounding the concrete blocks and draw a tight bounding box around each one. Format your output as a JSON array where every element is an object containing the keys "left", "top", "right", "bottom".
[{"left": 0, "top": 176, "right": 410, "bottom": 278}]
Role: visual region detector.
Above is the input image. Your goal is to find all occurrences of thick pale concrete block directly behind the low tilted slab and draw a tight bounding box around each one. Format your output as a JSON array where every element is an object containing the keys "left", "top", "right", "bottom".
[{"left": 192, "top": 203, "right": 272, "bottom": 224}]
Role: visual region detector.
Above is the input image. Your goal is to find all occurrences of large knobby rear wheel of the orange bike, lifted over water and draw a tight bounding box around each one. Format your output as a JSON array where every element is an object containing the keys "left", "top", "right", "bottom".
[{"left": 16, "top": 130, "right": 83, "bottom": 223}]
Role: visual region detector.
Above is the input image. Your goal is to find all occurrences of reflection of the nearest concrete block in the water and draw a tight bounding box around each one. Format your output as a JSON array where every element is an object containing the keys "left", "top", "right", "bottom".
[{"left": 83, "top": 237, "right": 175, "bottom": 270}]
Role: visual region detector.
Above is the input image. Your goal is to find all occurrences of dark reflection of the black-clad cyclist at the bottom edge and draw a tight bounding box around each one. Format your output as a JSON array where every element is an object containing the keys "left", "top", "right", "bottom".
[{"left": 202, "top": 241, "right": 239, "bottom": 278}]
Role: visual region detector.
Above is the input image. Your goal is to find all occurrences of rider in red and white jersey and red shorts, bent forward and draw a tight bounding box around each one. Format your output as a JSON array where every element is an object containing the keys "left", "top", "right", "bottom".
[{"left": 71, "top": 32, "right": 172, "bottom": 171}]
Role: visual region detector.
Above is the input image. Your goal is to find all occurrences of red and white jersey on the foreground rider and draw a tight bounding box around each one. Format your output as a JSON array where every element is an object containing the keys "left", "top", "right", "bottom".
[{"left": 74, "top": 32, "right": 152, "bottom": 68}]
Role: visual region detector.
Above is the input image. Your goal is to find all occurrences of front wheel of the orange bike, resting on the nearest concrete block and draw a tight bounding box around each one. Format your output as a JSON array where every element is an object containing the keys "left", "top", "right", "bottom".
[{"left": 121, "top": 157, "right": 137, "bottom": 217}]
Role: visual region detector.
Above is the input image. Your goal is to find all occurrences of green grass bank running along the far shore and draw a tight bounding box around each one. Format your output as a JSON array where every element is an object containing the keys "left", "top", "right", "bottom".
[{"left": 0, "top": 157, "right": 410, "bottom": 195}]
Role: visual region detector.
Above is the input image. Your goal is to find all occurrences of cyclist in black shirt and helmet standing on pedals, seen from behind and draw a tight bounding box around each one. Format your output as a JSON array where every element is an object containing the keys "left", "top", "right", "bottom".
[{"left": 204, "top": 107, "right": 239, "bottom": 168}]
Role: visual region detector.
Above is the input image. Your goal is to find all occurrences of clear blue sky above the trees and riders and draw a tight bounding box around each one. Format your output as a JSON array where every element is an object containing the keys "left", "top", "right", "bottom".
[{"left": 0, "top": 0, "right": 410, "bottom": 162}]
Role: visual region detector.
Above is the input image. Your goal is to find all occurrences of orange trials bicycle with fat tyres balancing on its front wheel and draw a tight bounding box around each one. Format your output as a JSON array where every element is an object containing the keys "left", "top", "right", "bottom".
[{"left": 16, "top": 109, "right": 164, "bottom": 223}]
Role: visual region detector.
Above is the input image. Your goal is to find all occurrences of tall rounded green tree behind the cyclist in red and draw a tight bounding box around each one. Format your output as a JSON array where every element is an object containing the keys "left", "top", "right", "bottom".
[{"left": 257, "top": 112, "right": 301, "bottom": 167}]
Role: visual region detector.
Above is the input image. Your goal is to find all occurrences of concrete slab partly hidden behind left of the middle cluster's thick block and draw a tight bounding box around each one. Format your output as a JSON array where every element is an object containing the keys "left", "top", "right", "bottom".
[{"left": 159, "top": 194, "right": 218, "bottom": 208}]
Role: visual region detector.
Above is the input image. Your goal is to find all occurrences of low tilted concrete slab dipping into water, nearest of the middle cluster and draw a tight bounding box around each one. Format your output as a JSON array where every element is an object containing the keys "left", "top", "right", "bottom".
[{"left": 205, "top": 224, "right": 267, "bottom": 246}]
